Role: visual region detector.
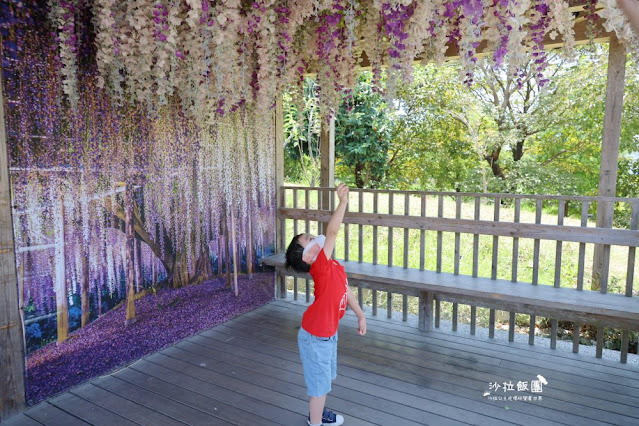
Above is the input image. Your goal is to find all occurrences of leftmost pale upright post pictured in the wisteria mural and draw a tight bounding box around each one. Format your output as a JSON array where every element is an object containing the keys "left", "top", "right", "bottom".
[{"left": 54, "top": 197, "right": 69, "bottom": 343}]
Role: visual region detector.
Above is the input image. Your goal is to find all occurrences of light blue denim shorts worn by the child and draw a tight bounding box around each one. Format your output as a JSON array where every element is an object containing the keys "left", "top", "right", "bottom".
[{"left": 297, "top": 327, "right": 337, "bottom": 396}]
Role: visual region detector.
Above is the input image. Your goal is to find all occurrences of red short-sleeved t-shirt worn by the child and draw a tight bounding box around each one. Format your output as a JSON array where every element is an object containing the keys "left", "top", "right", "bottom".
[{"left": 302, "top": 250, "right": 348, "bottom": 337}]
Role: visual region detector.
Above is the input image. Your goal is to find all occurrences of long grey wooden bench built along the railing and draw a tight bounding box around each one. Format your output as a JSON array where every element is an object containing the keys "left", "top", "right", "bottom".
[{"left": 261, "top": 253, "right": 639, "bottom": 331}]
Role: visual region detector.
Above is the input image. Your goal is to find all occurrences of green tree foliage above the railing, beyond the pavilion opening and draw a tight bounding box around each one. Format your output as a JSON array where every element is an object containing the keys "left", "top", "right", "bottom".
[{"left": 285, "top": 44, "right": 639, "bottom": 205}]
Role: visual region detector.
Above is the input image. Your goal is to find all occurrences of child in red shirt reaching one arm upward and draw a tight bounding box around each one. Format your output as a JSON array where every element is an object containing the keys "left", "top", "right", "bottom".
[{"left": 286, "top": 184, "right": 366, "bottom": 426}]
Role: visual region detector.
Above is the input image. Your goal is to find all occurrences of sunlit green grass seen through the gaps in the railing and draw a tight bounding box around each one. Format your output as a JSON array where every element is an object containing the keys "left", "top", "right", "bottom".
[{"left": 286, "top": 191, "right": 639, "bottom": 350}]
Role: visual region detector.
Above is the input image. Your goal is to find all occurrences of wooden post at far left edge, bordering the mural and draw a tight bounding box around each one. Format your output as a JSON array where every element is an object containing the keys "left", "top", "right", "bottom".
[{"left": 0, "top": 75, "right": 25, "bottom": 422}]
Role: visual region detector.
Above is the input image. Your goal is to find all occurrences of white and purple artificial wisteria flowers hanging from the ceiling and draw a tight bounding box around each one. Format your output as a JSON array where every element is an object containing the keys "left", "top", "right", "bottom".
[{"left": 40, "top": 0, "right": 638, "bottom": 123}]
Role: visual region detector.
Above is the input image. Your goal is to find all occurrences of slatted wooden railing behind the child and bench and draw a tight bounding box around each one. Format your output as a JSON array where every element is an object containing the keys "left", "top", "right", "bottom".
[{"left": 278, "top": 186, "right": 639, "bottom": 362}]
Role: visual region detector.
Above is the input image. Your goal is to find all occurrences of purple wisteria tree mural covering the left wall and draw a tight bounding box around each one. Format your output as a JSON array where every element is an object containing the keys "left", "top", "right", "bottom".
[{"left": 0, "top": 3, "right": 275, "bottom": 403}]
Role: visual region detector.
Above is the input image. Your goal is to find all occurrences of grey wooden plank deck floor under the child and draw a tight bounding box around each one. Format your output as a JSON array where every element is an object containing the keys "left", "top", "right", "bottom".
[{"left": 6, "top": 301, "right": 639, "bottom": 426}]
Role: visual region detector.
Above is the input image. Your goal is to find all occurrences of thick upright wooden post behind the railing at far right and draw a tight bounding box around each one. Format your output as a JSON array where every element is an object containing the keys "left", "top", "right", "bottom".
[{"left": 591, "top": 37, "right": 626, "bottom": 292}]
